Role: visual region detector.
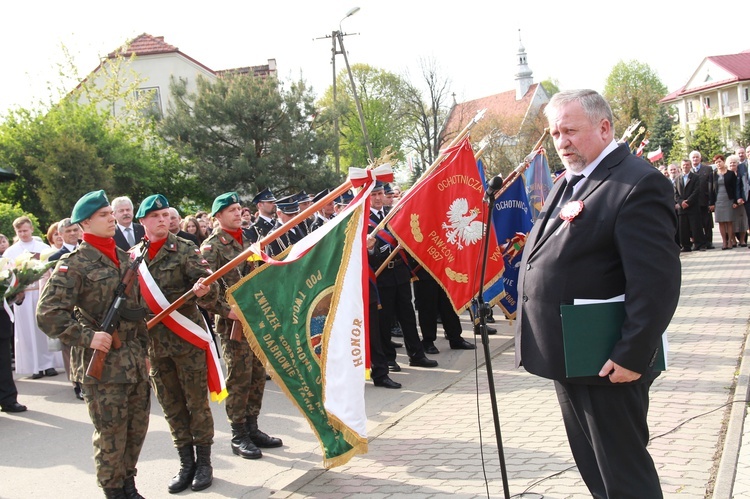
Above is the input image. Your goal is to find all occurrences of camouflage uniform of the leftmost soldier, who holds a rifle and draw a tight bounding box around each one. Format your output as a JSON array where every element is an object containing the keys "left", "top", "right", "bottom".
[{"left": 37, "top": 242, "right": 151, "bottom": 489}]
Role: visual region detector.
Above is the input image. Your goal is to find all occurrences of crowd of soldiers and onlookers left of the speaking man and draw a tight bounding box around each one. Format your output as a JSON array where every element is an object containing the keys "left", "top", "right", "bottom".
[{"left": 0, "top": 178, "right": 475, "bottom": 498}]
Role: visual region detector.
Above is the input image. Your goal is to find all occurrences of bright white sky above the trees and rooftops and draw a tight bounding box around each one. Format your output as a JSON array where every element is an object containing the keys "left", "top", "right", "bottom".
[{"left": 0, "top": 0, "right": 750, "bottom": 115}]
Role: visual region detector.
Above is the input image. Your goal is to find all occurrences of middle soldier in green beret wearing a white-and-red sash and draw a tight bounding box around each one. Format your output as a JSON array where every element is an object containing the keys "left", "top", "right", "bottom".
[{"left": 135, "top": 194, "right": 220, "bottom": 494}]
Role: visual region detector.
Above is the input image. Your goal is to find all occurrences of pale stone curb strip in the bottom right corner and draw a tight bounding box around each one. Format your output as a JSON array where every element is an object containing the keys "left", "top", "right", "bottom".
[{"left": 712, "top": 324, "right": 750, "bottom": 499}]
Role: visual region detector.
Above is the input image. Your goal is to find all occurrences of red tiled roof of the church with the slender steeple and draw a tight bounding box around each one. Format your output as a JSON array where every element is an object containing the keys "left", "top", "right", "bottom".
[{"left": 443, "top": 83, "right": 539, "bottom": 137}]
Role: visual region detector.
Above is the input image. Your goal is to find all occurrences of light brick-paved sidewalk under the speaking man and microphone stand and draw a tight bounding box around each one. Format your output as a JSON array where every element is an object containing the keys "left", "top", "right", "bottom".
[{"left": 272, "top": 248, "right": 750, "bottom": 499}]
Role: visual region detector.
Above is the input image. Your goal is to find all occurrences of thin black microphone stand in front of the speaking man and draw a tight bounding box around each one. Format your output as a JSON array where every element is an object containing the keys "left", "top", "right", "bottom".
[{"left": 472, "top": 193, "right": 510, "bottom": 499}]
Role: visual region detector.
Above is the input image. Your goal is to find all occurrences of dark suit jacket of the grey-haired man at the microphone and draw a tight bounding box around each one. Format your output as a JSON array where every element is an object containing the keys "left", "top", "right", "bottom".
[{"left": 516, "top": 145, "right": 681, "bottom": 384}]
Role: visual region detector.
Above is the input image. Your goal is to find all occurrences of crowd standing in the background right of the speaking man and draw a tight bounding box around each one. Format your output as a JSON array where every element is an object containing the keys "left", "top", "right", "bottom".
[{"left": 660, "top": 147, "right": 750, "bottom": 253}]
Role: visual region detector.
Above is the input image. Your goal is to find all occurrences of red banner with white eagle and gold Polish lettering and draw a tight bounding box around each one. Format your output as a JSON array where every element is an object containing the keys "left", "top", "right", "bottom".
[{"left": 388, "top": 138, "right": 504, "bottom": 313}]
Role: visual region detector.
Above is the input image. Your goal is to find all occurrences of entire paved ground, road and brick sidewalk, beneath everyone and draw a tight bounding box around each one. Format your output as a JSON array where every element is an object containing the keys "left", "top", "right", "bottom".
[{"left": 0, "top": 248, "right": 750, "bottom": 499}]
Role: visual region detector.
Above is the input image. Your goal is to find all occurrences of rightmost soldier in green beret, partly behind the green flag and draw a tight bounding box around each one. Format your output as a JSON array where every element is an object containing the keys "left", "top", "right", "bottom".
[{"left": 201, "top": 192, "right": 282, "bottom": 459}]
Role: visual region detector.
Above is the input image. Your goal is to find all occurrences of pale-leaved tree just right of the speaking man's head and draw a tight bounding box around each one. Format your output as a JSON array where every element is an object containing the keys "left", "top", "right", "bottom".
[{"left": 603, "top": 61, "right": 667, "bottom": 137}]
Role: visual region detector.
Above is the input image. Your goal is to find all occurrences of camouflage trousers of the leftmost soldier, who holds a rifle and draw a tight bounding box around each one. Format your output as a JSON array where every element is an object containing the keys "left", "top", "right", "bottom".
[{"left": 84, "top": 381, "right": 151, "bottom": 488}]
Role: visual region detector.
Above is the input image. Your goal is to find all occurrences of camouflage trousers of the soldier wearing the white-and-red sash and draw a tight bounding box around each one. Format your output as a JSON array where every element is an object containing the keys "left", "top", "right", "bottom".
[{"left": 149, "top": 348, "right": 214, "bottom": 448}]
